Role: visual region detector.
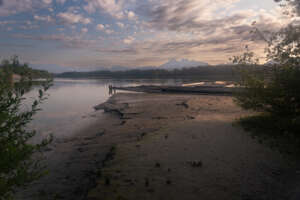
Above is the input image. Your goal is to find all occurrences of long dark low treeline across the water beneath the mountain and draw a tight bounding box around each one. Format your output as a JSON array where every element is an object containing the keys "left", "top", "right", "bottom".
[{"left": 55, "top": 65, "right": 244, "bottom": 81}]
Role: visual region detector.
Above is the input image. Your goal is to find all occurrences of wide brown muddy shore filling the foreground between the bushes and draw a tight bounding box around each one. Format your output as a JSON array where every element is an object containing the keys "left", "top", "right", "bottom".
[{"left": 17, "top": 93, "right": 299, "bottom": 200}]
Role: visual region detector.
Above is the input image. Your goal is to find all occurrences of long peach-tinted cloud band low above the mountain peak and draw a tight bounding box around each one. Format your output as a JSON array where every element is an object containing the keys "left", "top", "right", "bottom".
[{"left": 94, "top": 26, "right": 265, "bottom": 65}]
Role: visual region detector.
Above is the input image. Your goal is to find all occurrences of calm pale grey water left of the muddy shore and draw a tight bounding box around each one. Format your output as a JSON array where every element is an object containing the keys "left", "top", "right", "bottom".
[{"left": 26, "top": 79, "right": 184, "bottom": 141}]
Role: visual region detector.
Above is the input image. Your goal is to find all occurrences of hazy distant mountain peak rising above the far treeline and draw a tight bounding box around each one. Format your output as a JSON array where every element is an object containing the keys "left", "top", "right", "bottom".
[{"left": 159, "top": 59, "right": 209, "bottom": 70}]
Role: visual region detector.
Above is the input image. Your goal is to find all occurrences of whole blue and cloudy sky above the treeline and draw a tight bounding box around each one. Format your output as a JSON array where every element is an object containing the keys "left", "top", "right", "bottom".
[{"left": 0, "top": 0, "right": 294, "bottom": 71}]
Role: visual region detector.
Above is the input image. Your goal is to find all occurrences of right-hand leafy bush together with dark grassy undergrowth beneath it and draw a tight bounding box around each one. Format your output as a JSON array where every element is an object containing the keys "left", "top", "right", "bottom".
[{"left": 232, "top": 25, "right": 300, "bottom": 152}]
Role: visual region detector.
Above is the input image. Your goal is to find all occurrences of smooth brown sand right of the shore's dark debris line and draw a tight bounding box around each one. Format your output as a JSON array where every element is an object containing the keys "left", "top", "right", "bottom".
[{"left": 88, "top": 94, "right": 299, "bottom": 200}]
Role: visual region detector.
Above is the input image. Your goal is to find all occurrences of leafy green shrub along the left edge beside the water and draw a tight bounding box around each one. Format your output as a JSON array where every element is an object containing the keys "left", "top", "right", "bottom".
[{"left": 0, "top": 59, "right": 51, "bottom": 200}]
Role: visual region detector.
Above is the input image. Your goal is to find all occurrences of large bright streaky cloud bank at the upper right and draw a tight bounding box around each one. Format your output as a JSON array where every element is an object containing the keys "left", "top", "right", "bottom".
[{"left": 131, "top": 0, "right": 286, "bottom": 54}]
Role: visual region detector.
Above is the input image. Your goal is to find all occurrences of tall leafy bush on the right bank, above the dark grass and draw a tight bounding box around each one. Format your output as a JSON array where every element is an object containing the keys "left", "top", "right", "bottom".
[{"left": 233, "top": 26, "right": 300, "bottom": 120}]
